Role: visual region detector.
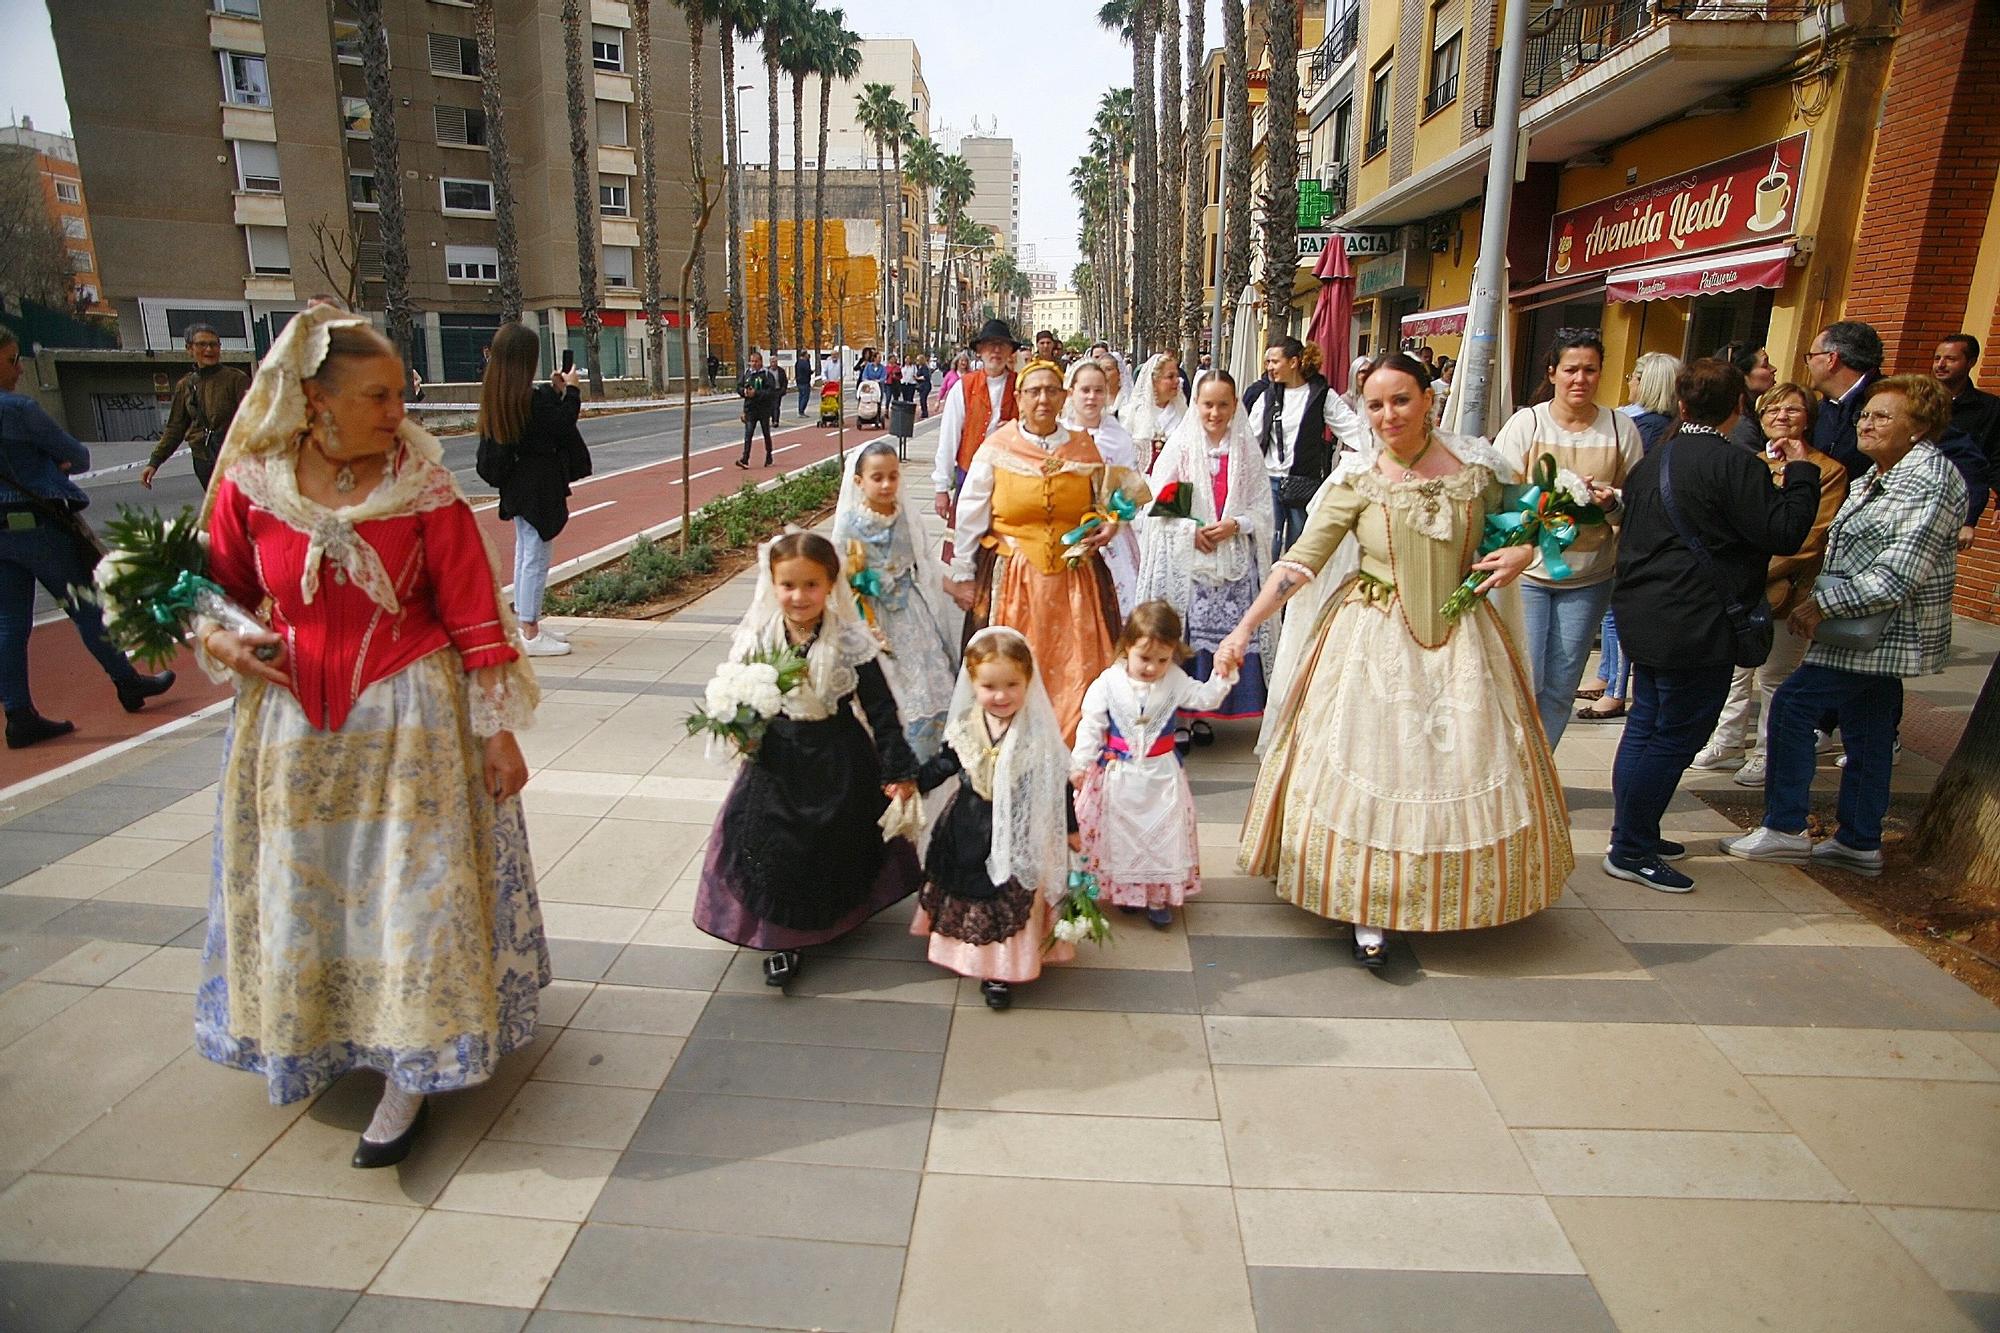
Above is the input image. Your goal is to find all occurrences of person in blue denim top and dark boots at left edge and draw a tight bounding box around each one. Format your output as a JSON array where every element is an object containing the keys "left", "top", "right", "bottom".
[{"left": 0, "top": 328, "right": 174, "bottom": 751}]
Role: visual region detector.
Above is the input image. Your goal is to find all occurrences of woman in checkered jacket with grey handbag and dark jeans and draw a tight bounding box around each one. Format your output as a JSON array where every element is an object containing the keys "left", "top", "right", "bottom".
[{"left": 1722, "top": 374, "right": 1966, "bottom": 877}]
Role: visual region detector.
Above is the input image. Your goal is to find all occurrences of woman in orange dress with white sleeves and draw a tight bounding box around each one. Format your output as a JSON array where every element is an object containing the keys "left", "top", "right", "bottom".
[{"left": 944, "top": 360, "right": 1152, "bottom": 745}]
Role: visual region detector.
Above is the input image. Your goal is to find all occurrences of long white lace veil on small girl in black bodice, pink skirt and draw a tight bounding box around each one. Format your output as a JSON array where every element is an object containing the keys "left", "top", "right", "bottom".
[{"left": 944, "top": 624, "right": 1070, "bottom": 905}]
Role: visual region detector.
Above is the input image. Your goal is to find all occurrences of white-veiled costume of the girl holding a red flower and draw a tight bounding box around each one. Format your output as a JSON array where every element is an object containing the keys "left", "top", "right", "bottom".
[{"left": 1138, "top": 404, "right": 1276, "bottom": 719}]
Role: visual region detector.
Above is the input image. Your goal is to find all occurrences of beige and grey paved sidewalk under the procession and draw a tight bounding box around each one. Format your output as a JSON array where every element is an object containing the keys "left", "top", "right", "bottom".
[{"left": 0, "top": 486, "right": 2000, "bottom": 1333}]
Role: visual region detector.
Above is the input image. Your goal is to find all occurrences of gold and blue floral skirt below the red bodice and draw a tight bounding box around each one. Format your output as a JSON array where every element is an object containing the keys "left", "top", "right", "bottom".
[{"left": 194, "top": 652, "right": 552, "bottom": 1103}]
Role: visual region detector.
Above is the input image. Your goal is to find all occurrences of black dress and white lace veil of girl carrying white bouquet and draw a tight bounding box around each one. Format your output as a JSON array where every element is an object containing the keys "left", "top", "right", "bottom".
[{"left": 694, "top": 546, "right": 918, "bottom": 960}]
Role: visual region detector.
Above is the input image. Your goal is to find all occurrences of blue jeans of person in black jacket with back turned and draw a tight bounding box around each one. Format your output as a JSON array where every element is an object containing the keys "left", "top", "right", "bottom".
[{"left": 1612, "top": 662, "right": 1736, "bottom": 861}]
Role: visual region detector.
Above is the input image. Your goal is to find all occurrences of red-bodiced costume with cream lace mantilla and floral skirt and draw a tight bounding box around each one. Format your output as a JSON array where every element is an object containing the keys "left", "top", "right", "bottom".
[{"left": 196, "top": 306, "right": 550, "bottom": 1103}]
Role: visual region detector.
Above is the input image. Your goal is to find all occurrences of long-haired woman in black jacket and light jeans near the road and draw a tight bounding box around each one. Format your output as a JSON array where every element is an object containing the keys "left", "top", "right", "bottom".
[{"left": 476, "top": 324, "right": 590, "bottom": 656}]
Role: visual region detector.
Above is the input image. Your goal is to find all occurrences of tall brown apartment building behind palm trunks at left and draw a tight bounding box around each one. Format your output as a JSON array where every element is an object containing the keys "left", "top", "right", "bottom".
[{"left": 50, "top": 0, "right": 724, "bottom": 380}]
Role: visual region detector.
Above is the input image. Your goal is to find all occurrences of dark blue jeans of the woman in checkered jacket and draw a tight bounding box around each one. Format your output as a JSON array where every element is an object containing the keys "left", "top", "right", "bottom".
[{"left": 1764, "top": 662, "right": 1902, "bottom": 851}]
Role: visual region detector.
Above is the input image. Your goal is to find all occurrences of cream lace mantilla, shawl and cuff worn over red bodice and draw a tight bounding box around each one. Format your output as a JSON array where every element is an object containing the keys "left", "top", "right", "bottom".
[{"left": 202, "top": 306, "right": 542, "bottom": 735}]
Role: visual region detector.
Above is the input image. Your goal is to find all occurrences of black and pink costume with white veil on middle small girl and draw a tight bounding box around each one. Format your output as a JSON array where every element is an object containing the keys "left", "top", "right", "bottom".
[{"left": 910, "top": 628, "right": 1076, "bottom": 992}]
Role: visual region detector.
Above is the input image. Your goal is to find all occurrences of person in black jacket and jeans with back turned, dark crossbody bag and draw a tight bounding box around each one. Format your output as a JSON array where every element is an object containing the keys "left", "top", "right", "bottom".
[{"left": 1604, "top": 358, "right": 1820, "bottom": 893}]
